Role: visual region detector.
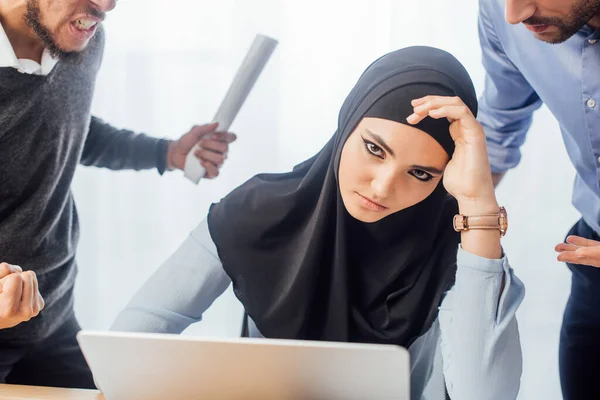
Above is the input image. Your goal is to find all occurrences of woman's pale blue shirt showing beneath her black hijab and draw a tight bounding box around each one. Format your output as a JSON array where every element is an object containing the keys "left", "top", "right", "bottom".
[{"left": 111, "top": 221, "right": 525, "bottom": 400}]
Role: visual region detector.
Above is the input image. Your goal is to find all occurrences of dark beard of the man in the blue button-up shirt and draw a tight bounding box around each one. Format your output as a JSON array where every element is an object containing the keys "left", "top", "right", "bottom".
[{"left": 523, "top": 0, "right": 600, "bottom": 44}]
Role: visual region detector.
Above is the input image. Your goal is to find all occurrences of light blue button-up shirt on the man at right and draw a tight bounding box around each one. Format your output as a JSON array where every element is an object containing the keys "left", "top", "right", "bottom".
[{"left": 478, "top": 0, "right": 600, "bottom": 232}]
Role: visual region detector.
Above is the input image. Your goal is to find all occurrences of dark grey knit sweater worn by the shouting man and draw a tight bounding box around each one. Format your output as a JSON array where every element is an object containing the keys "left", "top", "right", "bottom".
[{"left": 0, "top": 30, "right": 167, "bottom": 344}]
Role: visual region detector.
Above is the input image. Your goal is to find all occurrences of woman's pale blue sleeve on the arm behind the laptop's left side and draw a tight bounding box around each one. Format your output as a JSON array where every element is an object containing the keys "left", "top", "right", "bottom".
[{"left": 111, "top": 220, "right": 231, "bottom": 333}]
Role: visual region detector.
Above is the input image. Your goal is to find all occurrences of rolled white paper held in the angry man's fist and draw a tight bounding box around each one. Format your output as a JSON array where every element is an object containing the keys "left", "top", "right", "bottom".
[{"left": 184, "top": 35, "right": 278, "bottom": 183}]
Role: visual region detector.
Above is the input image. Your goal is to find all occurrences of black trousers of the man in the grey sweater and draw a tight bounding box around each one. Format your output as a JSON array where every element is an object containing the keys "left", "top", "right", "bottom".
[{"left": 0, "top": 315, "right": 96, "bottom": 389}]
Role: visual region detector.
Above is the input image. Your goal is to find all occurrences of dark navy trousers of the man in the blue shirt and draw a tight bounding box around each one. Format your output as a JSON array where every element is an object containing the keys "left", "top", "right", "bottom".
[{"left": 559, "top": 220, "right": 600, "bottom": 400}]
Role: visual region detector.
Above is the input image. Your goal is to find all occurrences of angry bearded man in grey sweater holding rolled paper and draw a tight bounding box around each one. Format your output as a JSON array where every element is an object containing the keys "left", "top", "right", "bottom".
[{"left": 0, "top": 0, "right": 235, "bottom": 388}]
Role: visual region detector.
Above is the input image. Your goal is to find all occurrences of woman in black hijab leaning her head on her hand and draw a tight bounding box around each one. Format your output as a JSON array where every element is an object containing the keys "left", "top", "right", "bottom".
[{"left": 113, "top": 47, "right": 523, "bottom": 400}]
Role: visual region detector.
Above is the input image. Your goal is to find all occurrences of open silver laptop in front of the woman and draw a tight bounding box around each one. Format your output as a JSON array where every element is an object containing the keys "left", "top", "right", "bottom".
[{"left": 77, "top": 331, "right": 410, "bottom": 400}]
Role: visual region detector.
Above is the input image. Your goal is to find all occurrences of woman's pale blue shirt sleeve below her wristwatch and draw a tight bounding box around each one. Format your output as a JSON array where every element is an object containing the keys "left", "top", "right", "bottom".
[{"left": 439, "top": 248, "right": 525, "bottom": 400}]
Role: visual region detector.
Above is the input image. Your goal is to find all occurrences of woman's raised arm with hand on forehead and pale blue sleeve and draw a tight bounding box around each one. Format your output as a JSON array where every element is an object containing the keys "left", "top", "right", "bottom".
[{"left": 409, "top": 96, "right": 525, "bottom": 400}]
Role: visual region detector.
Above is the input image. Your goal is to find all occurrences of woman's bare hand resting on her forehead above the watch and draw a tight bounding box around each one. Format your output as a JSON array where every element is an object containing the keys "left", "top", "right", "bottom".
[{"left": 407, "top": 96, "right": 498, "bottom": 214}]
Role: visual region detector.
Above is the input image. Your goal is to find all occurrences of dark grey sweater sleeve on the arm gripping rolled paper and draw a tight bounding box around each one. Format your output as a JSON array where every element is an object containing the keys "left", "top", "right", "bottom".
[{"left": 81, "top": 116, "right": 169, "bottom": 175}]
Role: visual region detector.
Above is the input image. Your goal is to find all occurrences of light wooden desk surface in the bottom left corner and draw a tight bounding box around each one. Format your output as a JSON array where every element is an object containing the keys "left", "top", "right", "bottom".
[{"left": 0, "top": 384, "right": 105, "bottom": 400}]
